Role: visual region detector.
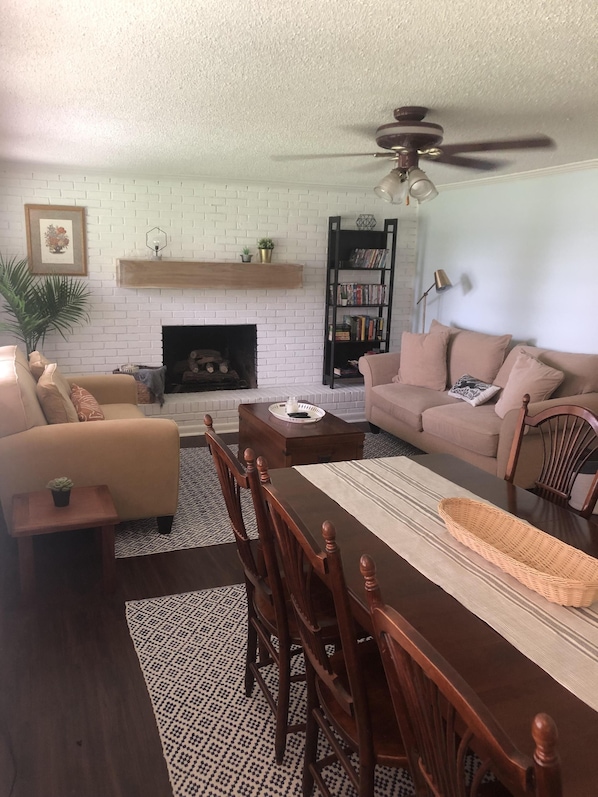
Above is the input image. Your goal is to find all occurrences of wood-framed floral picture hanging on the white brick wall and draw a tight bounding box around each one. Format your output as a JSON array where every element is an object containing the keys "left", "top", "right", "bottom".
[{"left": 25, "top": 205, "right": 87, "bottom": 277}]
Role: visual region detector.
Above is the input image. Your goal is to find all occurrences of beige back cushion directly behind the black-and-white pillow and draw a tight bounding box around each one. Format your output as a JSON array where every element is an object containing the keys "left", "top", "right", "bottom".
[{"left": 430, "top": 319, "right": 511, "bottom": 386}]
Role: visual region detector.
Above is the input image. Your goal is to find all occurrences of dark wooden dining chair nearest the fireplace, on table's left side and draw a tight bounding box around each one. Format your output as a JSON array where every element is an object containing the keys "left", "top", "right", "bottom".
[{"left": 204, "top": 415, "right": 305, "bottom": 764}]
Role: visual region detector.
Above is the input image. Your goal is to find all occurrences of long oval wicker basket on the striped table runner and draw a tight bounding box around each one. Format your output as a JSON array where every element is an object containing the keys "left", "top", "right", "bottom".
[{"left": 438, "top": 498, "right": 598, "bottom": 606}]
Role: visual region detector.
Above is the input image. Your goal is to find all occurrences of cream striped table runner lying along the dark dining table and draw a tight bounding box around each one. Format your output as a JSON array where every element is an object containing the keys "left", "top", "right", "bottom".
[{"left": 296, "top": 457, "right": 598, "bottom": 711}]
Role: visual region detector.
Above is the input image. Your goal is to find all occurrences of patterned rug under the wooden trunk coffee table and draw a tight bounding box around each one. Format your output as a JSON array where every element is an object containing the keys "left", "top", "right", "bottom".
[{"left": 115, "top": 432, "right": 422, "bottom": 558}]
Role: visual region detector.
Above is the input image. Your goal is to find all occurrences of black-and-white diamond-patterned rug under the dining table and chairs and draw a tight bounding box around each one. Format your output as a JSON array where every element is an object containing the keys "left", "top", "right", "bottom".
[{"left": 126, "top": 584, "right": 414, "bottom": 797}]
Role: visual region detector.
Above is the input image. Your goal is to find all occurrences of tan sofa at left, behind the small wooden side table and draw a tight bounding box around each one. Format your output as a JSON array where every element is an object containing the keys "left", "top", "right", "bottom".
[{"left": 0, "top": 346, "right": 180, "bottom": 533}]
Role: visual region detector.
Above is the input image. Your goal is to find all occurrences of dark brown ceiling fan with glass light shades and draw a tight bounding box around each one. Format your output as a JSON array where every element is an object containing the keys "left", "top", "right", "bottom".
[{"left": 278, "top": 105, "right": 554, "bottom": 204}]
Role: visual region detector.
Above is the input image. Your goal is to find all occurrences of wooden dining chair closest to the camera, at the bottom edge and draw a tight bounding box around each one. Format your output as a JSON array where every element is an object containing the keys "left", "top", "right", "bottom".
[{"left": 360, "top": 554, "right": 562, "bottom": 797}]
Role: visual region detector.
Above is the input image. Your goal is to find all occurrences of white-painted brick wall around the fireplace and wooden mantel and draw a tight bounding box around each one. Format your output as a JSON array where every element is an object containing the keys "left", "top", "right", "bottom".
[{"left": 0, "top": 169, "right": 417, "bottom": 380}]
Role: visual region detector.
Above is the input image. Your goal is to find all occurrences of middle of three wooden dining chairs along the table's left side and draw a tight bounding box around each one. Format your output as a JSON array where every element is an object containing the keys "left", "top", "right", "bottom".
[{"left": 257, "top": 457, "right": 407, "bottom": 797}]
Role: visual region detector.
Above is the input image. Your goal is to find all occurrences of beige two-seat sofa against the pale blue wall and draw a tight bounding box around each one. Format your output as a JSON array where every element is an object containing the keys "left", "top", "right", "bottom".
[{"left": 359, "top": 323, "right": 598, "bottom": 487}]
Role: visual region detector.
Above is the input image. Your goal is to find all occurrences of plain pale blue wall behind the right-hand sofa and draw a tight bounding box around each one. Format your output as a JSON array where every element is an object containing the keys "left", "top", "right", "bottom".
[{"left": 414, "top": 163, "right": 598, "bottom": 353}]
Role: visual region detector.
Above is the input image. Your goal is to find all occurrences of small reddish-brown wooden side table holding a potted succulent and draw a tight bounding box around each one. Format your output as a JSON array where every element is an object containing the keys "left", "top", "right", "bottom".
[{"left": 11, "top": 484, "right": 119, "bottom": 600}]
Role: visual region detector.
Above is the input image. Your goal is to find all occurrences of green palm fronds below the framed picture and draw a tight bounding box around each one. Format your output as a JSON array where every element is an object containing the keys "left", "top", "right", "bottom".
[{"left": 0, "top": 255, "right": 91, "bottom": 353}]
